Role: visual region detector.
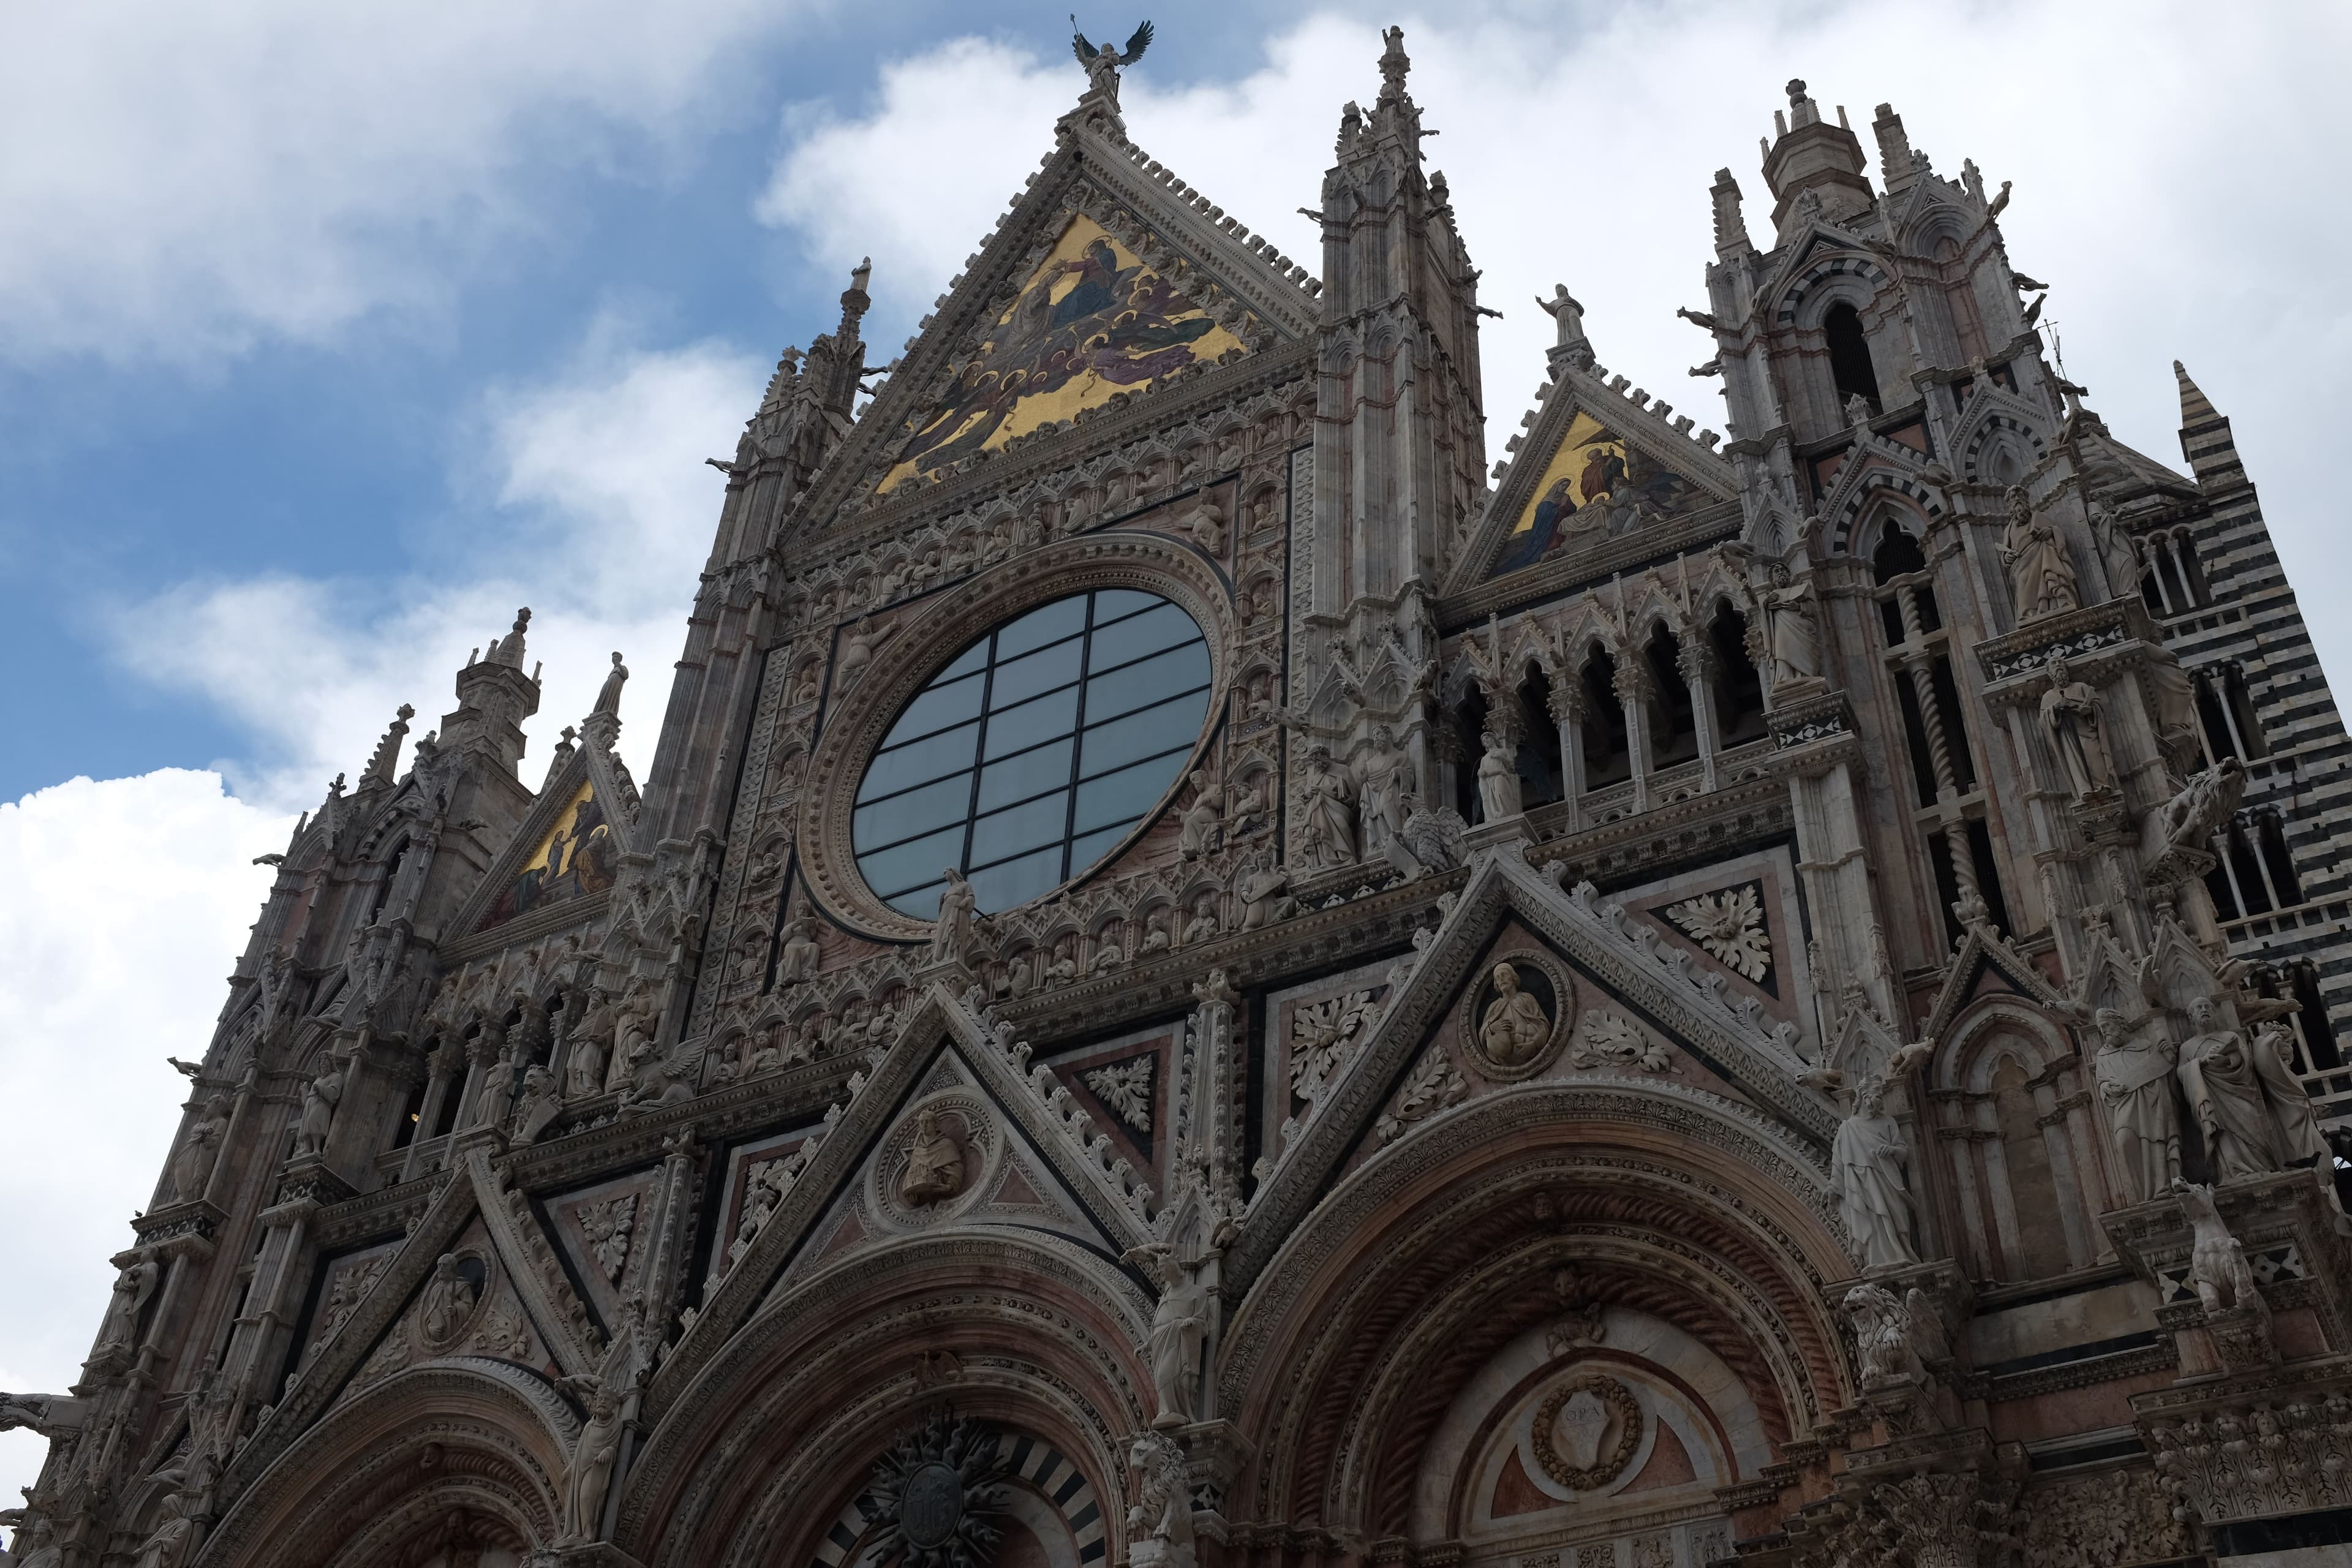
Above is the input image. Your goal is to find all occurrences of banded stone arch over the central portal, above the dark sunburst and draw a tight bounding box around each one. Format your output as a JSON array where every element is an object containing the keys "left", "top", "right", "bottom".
[{"left": 616, "top": 1227, "right": 1150, "bottom": 1568}]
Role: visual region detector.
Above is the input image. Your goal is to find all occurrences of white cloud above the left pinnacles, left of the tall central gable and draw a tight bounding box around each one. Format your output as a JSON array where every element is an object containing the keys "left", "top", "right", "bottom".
[{"left": 110, "top": 331, "right": 764, "bottom": 811}]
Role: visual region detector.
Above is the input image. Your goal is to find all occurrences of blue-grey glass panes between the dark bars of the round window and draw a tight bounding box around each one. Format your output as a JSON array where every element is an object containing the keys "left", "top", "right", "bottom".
[{"left": 859, "top": 590, "right": 1209, "bottom": 919}]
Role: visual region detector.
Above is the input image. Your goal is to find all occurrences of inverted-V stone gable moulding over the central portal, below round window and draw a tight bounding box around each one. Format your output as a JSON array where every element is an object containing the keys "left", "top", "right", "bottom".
[{"left": 647, "top": 980, "right": 1153, "bottom": 1417}]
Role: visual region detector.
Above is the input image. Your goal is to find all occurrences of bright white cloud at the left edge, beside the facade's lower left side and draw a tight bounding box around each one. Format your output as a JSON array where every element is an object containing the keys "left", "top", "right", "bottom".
[{"left": 0, "top": 769, "right": 292, "bottom": 1498}]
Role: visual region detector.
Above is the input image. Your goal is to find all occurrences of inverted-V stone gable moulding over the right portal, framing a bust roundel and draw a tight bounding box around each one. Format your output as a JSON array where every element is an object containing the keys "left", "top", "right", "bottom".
[{"left": 1226, "top": 846, "right": 1837, "bottom": 1288}]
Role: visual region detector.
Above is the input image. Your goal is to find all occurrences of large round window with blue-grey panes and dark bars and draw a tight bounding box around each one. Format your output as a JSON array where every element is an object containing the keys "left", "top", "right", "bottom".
[{"left": 849, "top": 588, "right": 1209, "bottom": 919}]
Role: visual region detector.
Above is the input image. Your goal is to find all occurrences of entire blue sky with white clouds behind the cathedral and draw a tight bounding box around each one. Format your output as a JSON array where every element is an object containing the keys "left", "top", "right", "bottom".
[{"left": 0, "top": 0, "right": 2352, "bottom": 1523}]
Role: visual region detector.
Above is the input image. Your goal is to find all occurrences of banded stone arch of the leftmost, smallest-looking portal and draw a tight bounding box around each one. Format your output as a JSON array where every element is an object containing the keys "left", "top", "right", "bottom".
[{"left": 190, "top": 1357, "right": 579, "bottom": 1568}]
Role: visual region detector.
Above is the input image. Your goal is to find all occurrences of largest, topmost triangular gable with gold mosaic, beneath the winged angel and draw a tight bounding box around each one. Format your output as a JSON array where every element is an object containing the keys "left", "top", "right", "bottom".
[{"left": 807, "top": 118, "right": 1317, "bottom": 527}]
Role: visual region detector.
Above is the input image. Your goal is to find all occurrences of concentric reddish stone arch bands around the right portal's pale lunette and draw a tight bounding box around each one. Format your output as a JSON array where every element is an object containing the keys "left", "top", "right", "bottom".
[{"left": 1218, "top": 1079, "right": 1853, "bottom": 1535}]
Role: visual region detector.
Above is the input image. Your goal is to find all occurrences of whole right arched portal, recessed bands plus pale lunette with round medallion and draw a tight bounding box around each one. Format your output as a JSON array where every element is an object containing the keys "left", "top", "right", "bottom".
[{"left": 1218, "top": 1082, "right": 1853, "bottom": 1561}]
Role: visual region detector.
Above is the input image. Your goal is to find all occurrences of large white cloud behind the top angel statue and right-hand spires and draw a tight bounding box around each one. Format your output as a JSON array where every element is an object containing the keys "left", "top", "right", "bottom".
[{"left": 760, "top": 0, "right": 2352, "bottom": 677}]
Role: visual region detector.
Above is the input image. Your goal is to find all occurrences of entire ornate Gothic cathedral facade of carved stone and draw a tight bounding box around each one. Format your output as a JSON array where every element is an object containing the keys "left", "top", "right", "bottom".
[{"left": 18, "top": 28, "right": 2352, "bottom": 1568}]
